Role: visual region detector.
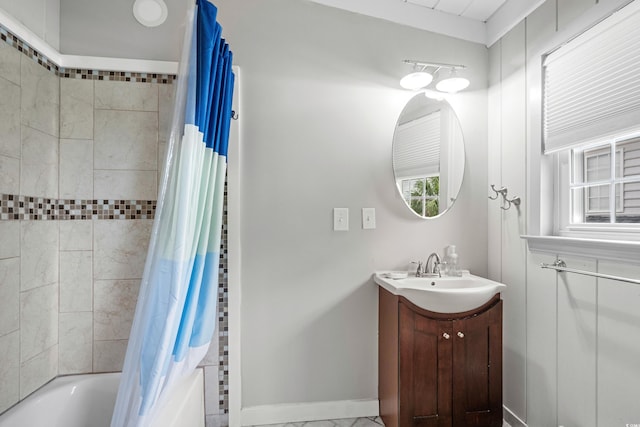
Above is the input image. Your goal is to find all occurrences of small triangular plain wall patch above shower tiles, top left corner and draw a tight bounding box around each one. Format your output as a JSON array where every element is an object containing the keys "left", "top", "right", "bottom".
[{"left": 0, "top": 0, "right": 60, "bottom": 49}]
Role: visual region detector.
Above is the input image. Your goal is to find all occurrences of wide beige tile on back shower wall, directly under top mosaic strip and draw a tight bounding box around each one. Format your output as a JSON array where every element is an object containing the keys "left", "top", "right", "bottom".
[{"left": 95, "top": 81, "right": 158, "bottom": 111}]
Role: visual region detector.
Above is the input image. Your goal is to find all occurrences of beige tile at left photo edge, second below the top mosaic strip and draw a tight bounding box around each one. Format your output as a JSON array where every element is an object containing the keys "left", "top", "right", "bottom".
[{"left": 0, "top": 78, "right": 20, "bottom": 159}]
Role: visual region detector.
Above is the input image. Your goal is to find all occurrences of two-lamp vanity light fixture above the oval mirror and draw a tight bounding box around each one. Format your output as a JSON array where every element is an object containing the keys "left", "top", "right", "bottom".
[{"left": 400, "top": 59, "right": 469, "bottom": 94}]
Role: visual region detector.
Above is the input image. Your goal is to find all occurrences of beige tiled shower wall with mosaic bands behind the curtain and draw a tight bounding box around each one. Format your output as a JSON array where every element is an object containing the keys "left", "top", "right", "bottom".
[{"left": 0, "top": 30, "right": 228, "bottom": 425}]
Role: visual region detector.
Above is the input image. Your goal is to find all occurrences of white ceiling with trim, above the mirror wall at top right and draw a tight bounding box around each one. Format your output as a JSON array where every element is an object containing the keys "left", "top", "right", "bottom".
[{"left": 304, "top": 0, "right": 545, "bottom": 46}]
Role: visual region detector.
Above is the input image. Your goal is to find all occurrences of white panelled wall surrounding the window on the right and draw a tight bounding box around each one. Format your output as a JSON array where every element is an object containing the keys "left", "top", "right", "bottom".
[{"left": 488, "top": 0, "right": 640, "bottom": 427}]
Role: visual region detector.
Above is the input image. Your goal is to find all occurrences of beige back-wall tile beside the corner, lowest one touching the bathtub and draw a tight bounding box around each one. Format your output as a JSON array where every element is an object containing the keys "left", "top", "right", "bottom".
[{"left": 58, "top": 312, "right": 93, "bottom": 375}]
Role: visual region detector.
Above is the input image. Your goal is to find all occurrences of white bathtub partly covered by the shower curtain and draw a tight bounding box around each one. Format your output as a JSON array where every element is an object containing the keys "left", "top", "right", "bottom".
[{"left": 0, "top": 369, "right": 204, "bottom": 427}]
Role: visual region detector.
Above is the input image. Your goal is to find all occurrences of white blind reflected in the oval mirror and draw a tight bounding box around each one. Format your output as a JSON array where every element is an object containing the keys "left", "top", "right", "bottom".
[{"left": 393, "top": 111, "right": 440, "bottom": 179}]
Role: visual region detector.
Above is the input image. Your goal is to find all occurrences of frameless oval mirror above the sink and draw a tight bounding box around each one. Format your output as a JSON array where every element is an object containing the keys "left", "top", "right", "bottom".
[{"left": 393, "top": 92, "right": 465, "bottom": 218}]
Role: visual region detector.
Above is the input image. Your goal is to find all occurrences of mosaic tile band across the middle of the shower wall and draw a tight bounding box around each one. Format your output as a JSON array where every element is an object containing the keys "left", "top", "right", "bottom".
[{"left": 0, "top": 194, "right": 156, "bottom": 221}]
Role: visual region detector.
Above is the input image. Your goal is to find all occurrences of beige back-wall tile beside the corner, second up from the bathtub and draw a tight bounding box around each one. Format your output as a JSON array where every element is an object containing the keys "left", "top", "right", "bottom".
[{"left": 60, "top": 251, "right": 93, "bottom": 313}]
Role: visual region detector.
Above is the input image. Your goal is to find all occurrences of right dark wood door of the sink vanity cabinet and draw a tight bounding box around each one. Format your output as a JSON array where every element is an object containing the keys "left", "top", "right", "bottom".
[{"left": 452, "top": 301, "right": 502, "bottom": 427}]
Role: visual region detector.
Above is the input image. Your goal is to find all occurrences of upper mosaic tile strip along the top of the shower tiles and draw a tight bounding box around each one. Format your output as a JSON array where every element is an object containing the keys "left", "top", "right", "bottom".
[{"left": 0, "top": 25, "right": 176, "bottom": 84}]
